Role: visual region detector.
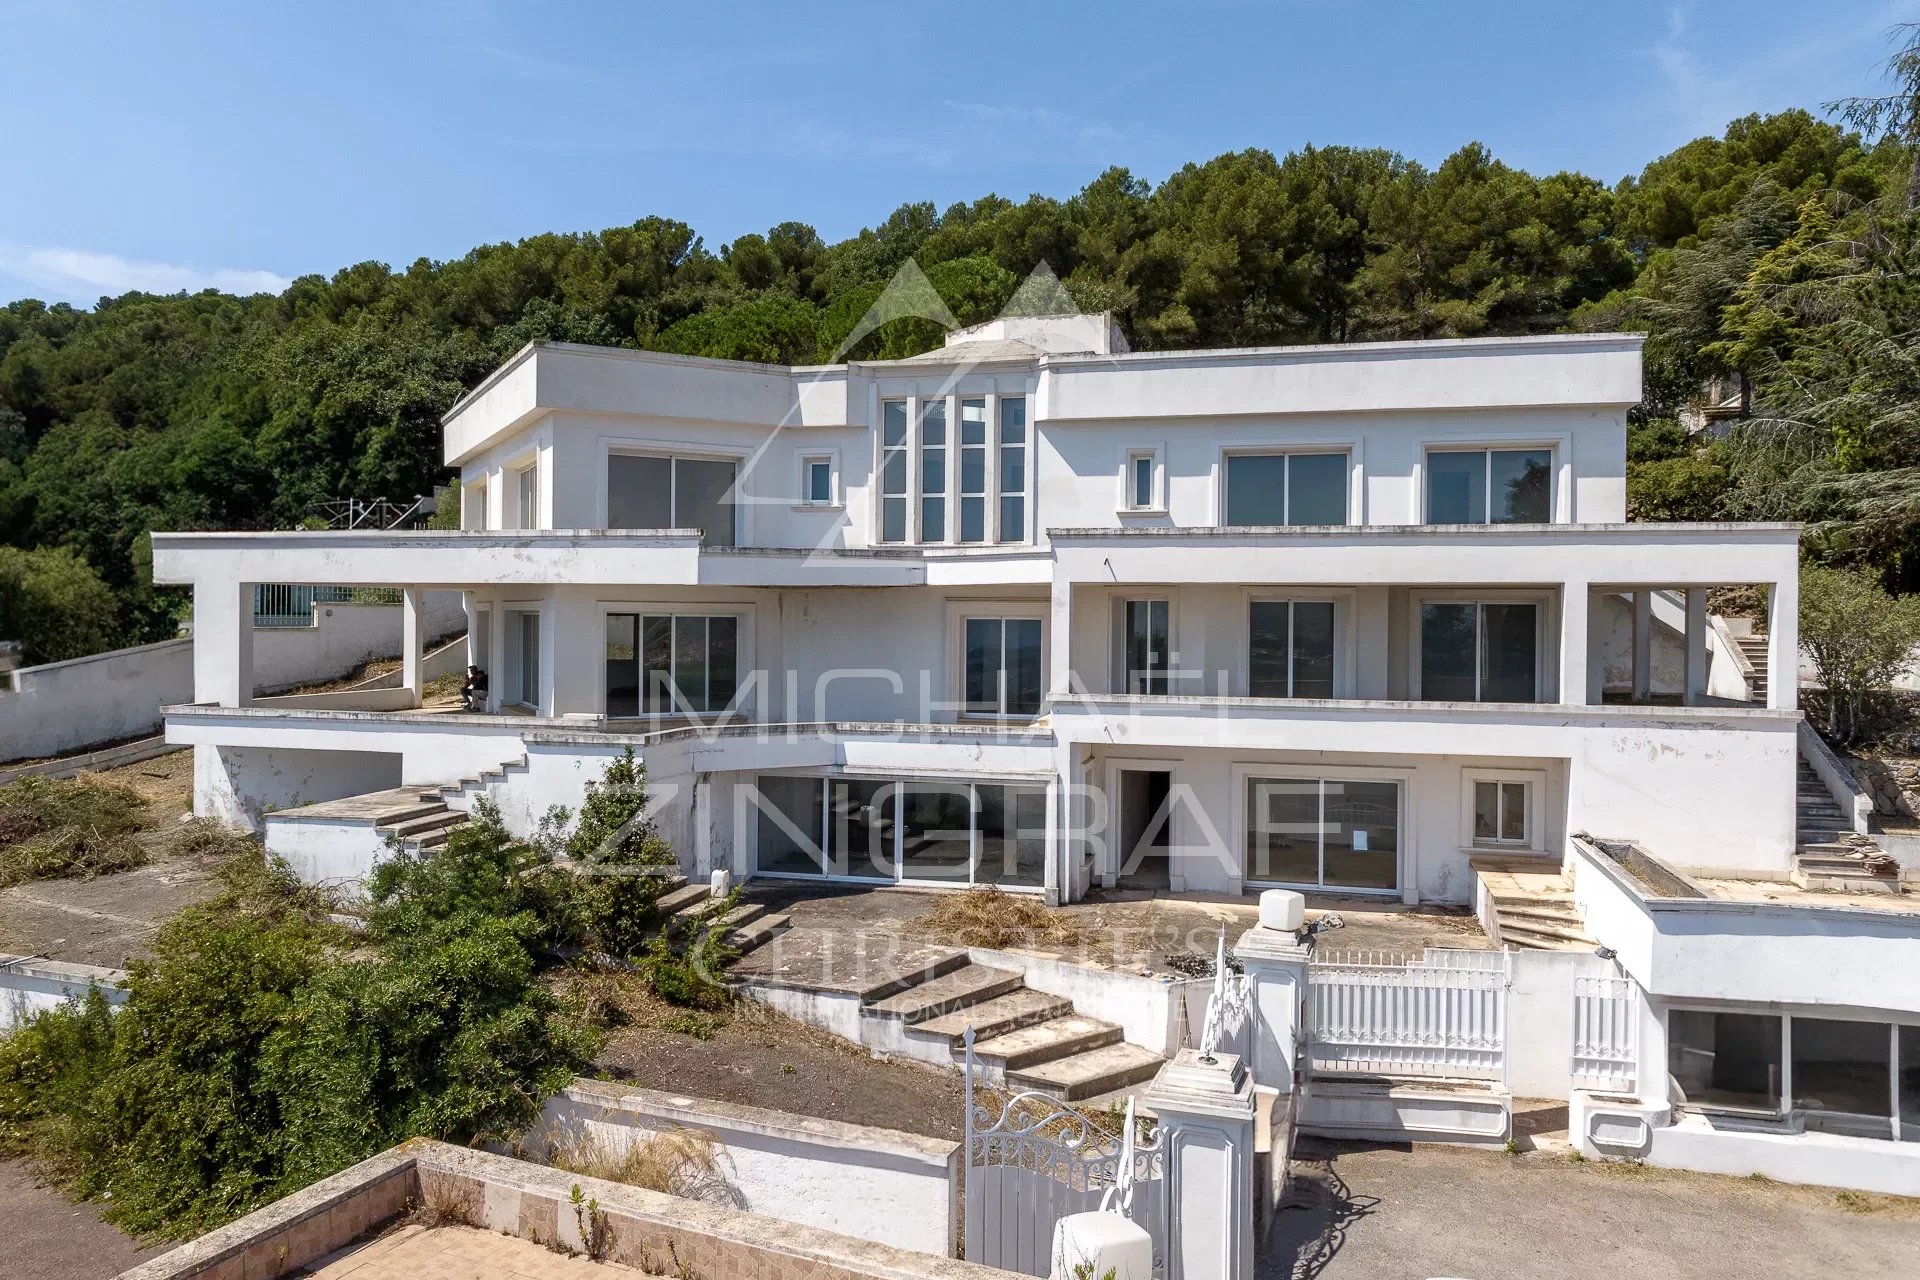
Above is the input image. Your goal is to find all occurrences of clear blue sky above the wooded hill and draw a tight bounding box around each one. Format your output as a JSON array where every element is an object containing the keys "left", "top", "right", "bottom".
[{"left": 0, "top": 0, "right": 1920, "bottom": 305}]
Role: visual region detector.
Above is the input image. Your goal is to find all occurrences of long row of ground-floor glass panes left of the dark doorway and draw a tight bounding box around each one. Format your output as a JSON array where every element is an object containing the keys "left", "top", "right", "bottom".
[{"left": 751, "top": 773, "right": 1046, "bottom": 889}]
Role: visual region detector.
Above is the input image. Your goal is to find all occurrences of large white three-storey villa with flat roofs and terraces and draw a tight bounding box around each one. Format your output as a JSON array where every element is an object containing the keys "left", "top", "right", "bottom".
[{"left": 154, "top": 315, "right": 1920, "bottom": 1194}]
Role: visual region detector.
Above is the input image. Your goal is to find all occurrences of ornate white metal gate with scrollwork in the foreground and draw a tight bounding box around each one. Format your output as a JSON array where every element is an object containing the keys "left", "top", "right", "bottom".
[{"left": 966, "top": 1031, "right": 1167, "bottom": 1276}]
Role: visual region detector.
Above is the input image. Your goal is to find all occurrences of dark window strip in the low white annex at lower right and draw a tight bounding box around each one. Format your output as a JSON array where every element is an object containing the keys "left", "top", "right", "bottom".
[{"left": 1667, "top": 1009, "right": 1920, "bottom": 1142}]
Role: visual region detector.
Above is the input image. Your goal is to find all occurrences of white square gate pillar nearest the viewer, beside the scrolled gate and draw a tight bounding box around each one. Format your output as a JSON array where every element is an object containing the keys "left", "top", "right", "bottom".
[{"left": 1142, "top": 1050, "right": 1258, "bottom": 1280}]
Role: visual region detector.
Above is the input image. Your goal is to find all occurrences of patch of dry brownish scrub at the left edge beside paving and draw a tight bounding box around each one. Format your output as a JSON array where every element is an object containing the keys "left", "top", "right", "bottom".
[{"left": 0, "top": 777, "right": 150, "bottom": 885}]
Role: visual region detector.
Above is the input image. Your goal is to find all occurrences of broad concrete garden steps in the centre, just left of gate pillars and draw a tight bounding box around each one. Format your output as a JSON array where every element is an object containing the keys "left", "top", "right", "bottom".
[{"left": 860, "top": 952, "right": 1165, "bottom": 1102}]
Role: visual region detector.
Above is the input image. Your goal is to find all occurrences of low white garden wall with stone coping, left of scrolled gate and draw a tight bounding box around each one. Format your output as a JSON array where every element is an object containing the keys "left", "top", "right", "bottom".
[{"left": 524, "top": 1080, "right": 962, "bottom": 1257}]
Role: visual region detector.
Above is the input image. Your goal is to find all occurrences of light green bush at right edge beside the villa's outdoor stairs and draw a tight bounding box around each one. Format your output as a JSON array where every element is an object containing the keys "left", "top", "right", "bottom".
[{"left": 1799, "top": 566, "right": 1920, "bottom": 743}]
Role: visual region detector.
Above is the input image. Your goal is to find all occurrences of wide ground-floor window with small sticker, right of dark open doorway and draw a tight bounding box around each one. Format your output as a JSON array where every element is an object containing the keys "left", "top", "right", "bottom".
[{"left": 1246, "top": 777, "right": 1400, "bottom": 890}]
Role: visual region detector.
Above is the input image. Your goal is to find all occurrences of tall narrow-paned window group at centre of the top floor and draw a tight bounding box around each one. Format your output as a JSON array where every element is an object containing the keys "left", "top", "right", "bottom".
[{"left": 879, "top": 395, "right": 1031, "bottom": 545}]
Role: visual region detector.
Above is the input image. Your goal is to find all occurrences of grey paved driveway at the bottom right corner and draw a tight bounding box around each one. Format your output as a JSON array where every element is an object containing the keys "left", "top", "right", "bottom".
[{"left": 1258, "top": 1140, "right": 1920, "bottom": 1280}]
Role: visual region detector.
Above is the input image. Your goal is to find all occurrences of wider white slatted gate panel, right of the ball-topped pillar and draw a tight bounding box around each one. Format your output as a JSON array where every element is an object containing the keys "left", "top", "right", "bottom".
[{"left": 1308, "top": 948, "right": 1513, "bottom": 1080}]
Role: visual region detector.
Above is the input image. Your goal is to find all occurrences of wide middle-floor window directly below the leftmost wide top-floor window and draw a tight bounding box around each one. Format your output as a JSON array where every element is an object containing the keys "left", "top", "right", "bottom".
[{"left": 607, "top": 614, "right": 739, "bottom": 716}]
